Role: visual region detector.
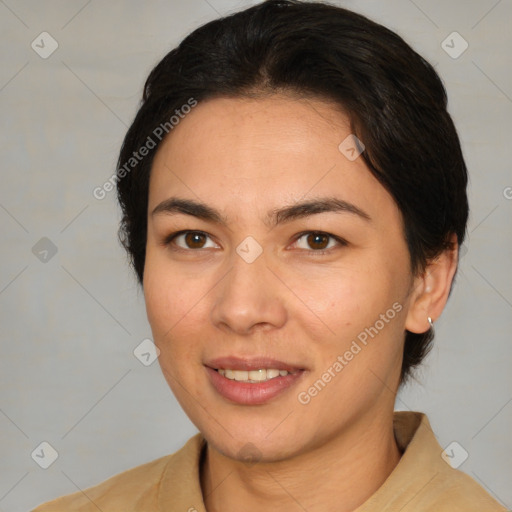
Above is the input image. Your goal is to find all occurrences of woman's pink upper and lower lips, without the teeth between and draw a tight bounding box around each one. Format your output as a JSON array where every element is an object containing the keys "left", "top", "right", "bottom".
[{"left": 205, "top": 357, "right": 305, "bottom": 405}]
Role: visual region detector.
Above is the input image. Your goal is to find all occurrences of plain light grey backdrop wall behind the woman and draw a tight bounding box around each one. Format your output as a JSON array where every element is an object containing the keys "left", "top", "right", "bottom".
[{"left": 0, "top": 0, "right": 512, "bottom": 512}]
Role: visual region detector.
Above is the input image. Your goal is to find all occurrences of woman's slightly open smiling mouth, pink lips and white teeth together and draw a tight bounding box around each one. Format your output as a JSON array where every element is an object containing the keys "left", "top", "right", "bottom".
[{"left": 205, "top": 357, "right": 306, "bottom": 405}]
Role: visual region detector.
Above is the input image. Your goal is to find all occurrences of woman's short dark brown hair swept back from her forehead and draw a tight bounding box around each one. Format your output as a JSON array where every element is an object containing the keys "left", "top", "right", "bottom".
[{"left": 117, "top": 0, "right": 468, "bottom": 384}]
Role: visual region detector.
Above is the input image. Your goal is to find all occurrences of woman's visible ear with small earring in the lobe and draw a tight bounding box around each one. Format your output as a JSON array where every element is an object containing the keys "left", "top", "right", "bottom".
[{"left": 405, "top": 234, "right": 459, "bottom": 334}]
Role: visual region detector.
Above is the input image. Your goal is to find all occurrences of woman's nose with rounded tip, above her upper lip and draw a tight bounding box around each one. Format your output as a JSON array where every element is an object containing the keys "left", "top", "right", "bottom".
[{"left": 211, "top": 249, "right": 287, "bottom": 335}]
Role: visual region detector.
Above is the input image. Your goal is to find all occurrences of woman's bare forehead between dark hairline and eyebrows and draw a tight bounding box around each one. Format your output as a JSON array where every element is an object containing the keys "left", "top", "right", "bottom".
[{"left": 149, "top": 96, "right": 396, "bottom": 229}]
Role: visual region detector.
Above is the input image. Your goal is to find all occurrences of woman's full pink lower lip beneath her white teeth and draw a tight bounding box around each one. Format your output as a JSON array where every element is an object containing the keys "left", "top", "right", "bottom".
[{"left": 205, "top": 366, "right": 304, "bottom": 405}]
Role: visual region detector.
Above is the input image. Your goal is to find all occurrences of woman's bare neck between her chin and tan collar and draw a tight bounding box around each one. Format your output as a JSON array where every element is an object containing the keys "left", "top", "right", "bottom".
[{"left": 201, "top": 411, "right": 400, "bottom": 512}]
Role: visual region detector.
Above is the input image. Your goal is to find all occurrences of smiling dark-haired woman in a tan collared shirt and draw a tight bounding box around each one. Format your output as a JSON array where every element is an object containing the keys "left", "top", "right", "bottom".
[{"left": 36, "top": 0, "right": 505, "bottom": 512}]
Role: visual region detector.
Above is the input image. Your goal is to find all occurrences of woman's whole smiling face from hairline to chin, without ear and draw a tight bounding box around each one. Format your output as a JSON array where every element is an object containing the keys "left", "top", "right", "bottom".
[{"left": 144, "top": 96, "right": 413, "bottom": 461}]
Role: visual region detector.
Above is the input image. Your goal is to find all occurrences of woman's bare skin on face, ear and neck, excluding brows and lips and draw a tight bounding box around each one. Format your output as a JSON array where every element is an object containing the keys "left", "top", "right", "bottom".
[{"left": 144, "top": 95, "right": 456, "bottom": 512}]
